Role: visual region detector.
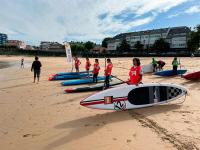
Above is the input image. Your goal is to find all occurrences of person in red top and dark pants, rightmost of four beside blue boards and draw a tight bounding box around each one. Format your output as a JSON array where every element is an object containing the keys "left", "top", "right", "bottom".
[{"left": 105, "top": 58, "right": 113, "bottom": 88}]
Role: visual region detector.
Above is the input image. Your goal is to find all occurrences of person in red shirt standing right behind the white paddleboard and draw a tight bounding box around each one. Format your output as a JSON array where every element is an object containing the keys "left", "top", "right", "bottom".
[{"left": 129, "top": 58, "right": 142, "bottom": 85}]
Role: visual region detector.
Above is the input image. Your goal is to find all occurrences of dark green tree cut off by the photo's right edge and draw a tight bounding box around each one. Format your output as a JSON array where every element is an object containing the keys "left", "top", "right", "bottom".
[{"left": 187, "top": 25, "right": 200, "bottom": 51}]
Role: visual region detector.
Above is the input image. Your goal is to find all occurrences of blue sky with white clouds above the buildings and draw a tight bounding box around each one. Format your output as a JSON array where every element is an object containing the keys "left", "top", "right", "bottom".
[{"left": 0, "top": 0, "right": 200, "bottom": 45}]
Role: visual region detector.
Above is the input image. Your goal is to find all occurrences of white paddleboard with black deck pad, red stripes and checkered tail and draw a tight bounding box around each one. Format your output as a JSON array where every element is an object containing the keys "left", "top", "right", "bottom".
[{"left": 80, "top": 83, "right": 187, "bottom": 110}]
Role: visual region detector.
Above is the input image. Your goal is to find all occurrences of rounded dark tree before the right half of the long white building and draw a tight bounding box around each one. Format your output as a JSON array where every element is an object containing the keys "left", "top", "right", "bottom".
[{"left": 151, "top": 38, "right": 170, "bottom": 52}]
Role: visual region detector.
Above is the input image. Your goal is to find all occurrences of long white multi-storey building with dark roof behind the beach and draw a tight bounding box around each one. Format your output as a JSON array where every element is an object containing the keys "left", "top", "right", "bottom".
[{"left": 108, "top": 26, "right": 191, "bottom": 51}]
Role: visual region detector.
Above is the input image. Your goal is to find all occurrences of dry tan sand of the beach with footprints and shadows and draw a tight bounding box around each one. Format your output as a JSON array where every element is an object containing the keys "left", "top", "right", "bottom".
[{"left": 0, "top": 56, "right": 200, "bottom": 150}]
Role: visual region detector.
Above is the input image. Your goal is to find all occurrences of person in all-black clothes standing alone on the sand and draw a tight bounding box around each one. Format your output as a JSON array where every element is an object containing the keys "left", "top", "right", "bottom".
[{"left": 31, "top": 56, "right": 42, "bottom": 83}]
